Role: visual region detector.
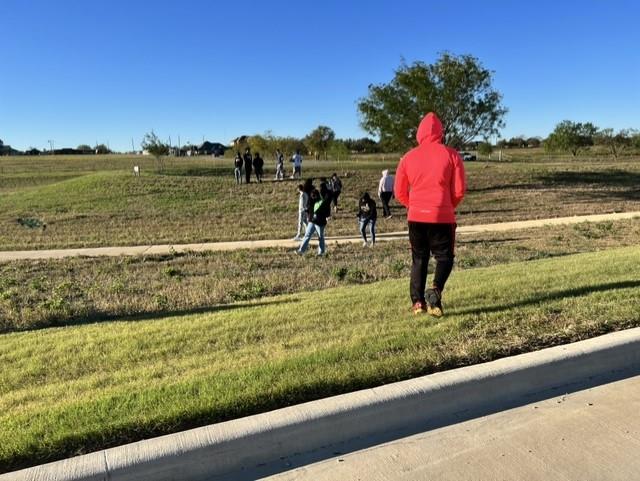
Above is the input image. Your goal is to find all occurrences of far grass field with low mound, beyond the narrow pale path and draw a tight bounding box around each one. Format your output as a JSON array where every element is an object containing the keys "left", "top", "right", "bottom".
[{"left": 0, "top": 156, "right": 640, "bottom": 250}]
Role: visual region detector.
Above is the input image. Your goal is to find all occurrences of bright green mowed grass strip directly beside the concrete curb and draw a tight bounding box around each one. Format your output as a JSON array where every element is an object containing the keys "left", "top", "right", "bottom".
[{"left": 0, "top": 246, "right": 640, "bottom": 471}]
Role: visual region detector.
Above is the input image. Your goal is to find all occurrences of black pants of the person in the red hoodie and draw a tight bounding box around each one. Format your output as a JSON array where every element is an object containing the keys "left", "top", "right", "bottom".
[{"left": 409, "top": 222, "right": 456, "bottom": 303}]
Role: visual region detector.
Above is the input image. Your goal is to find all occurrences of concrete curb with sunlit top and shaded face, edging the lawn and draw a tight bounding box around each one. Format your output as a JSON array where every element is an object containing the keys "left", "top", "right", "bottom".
[{"left": 5, "top": 328, "right": 640, "bottom": 481}]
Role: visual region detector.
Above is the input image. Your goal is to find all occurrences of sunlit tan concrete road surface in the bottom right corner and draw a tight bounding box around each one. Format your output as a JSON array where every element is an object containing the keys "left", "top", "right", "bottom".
[{"left": 264, "top": 376, "right": 640, "bottom": 481}]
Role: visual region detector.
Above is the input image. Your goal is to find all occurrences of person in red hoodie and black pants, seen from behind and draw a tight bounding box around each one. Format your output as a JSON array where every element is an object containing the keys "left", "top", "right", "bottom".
[{"left": 393, "top": 112, "right": 466, "bottom": 317}]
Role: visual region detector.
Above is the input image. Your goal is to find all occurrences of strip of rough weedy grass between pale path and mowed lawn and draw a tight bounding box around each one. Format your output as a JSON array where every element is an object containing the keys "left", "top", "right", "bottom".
[{"left": 0, "top": 219, "right": 640, "bottom": 333}]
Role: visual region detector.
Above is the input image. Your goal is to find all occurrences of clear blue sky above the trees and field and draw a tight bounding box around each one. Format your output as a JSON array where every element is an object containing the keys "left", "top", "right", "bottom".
[{"left": 0, "top": 0, "right": 640, "bottom": 150}]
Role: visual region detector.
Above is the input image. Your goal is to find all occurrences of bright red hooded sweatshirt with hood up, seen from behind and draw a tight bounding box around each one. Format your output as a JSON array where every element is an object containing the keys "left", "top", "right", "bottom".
[{"left": 393, "top": 113, "right": 466, "bottom": 224}]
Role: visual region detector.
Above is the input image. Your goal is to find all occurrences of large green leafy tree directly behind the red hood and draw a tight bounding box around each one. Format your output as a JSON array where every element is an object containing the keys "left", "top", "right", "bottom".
[{"left": 358, "top": 53, "right": 507, "bottom": 150}]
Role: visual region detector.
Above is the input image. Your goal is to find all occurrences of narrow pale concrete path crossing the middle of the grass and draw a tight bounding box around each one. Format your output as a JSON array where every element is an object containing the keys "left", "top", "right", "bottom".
[{"left": 0, "top": 212, "right": 640, "bottom": 262}]
